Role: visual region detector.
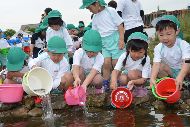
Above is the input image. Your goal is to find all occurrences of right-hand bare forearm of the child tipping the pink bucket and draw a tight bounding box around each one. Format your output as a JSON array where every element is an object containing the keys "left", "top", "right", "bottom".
[{"left": 82, "top": 68, "right": 98, "bottom": 92}]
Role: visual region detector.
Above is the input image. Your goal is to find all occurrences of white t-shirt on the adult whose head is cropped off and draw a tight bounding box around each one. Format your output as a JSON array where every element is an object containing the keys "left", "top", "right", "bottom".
[{"left": 116, "top": 0, "right": 144, "bottom": 30}]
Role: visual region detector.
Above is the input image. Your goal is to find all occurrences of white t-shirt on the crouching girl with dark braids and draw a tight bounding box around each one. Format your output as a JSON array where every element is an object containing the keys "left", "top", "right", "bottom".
[{"left": 114, "top": 52, "right": 151, "bottom": 78}]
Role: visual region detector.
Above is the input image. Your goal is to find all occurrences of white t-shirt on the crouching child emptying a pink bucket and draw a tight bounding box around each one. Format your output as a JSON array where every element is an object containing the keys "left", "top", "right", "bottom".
[{"left": 73, "top": 48, "right": 104, "bottom": 73}]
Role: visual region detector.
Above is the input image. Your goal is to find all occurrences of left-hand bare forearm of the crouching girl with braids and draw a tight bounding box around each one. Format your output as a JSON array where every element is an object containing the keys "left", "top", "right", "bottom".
[{"left": 111, "top": 69, "right": 119, "bottom": 90}]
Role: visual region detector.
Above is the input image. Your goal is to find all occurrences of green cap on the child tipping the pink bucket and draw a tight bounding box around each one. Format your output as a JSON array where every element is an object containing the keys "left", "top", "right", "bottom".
[{"left": 83, "top": 30, "right": 102, "bottom": 52}]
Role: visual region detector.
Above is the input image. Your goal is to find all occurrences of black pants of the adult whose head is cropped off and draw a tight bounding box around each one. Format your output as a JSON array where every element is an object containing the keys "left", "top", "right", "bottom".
[{"left": 124, "top": 26, "right": 143, "bottom": 44}]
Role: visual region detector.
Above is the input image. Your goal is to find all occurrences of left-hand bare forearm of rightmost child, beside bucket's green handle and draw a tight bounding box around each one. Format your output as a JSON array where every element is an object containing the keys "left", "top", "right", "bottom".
[{"left": 150, "top": 62, "right": 160, "bottom": 88}]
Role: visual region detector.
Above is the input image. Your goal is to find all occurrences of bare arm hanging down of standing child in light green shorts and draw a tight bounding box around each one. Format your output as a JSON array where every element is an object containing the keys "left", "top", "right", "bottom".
[{"left": 118, "top": 23, "right": 125, "bottom": 50}]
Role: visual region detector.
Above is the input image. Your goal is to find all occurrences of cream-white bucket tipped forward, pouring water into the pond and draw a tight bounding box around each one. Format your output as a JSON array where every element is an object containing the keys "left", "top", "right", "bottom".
[{"left": 22, "top": 67, "right": 53, "bottom": 96}]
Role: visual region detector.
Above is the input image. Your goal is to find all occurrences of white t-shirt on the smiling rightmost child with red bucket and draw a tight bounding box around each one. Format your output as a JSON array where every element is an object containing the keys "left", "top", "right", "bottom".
[{"left": 153, "top": 38, "right": 190, "bottom": 69}]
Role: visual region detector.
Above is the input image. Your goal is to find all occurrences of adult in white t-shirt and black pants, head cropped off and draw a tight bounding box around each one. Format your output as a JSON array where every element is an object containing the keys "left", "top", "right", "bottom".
[{"left": 116, "top": 0, "right": 144, "bottom": 43}]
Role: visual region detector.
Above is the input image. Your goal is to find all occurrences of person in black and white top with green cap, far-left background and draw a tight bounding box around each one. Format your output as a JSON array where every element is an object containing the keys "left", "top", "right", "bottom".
[{"left": 30, "top": 26, "right": 47, "bottom": 58}]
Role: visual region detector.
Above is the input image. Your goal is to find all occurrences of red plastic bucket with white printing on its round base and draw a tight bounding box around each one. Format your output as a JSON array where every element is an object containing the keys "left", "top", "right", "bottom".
[{"left": 111, "top": 87, "right": 133, "bottom": 109}]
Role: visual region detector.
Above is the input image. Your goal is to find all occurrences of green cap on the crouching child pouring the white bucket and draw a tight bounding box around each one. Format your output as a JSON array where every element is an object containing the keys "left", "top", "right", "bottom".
[{"left": 47, "top": 36, "right": 67, "bottom": 53}]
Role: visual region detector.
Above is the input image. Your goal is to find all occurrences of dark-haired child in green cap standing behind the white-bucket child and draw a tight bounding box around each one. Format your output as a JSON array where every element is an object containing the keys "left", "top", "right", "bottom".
[{"left": 46, "top": 10, "right": 73, "bottom": 62}]
